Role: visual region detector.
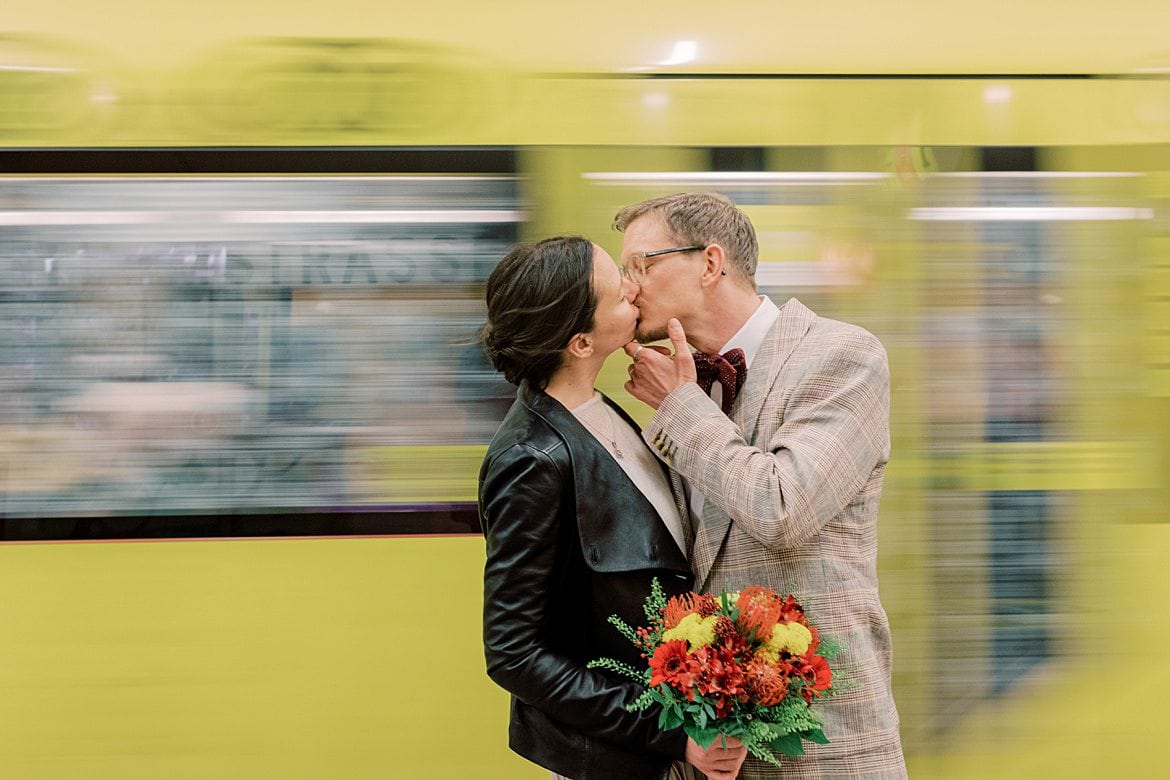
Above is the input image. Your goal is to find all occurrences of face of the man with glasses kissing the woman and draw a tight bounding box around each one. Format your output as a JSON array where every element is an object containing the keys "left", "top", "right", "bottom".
[{"left": 621, "top": 214, "right": 703, "bottom": 341}]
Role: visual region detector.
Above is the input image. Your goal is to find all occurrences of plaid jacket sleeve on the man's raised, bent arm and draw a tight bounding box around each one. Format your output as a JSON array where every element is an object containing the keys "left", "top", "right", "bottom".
[{"left": 644, "top": 329, "right": 889, "bottom": 550}]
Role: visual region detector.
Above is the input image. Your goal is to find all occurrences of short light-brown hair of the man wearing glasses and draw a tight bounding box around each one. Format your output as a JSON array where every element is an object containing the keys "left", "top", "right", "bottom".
[{"left": 613, "top": 192, "right": 759, "bottom": 288}]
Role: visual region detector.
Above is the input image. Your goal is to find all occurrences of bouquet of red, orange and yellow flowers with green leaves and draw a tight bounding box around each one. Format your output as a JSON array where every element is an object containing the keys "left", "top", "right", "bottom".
[{"left": 589, "top": 580, "right": 840, "bottom": 766}]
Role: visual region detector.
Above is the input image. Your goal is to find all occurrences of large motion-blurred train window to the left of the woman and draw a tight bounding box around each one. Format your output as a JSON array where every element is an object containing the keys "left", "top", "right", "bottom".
[{"left": 0, "top": 161, "right": 523, "bottom": 538}]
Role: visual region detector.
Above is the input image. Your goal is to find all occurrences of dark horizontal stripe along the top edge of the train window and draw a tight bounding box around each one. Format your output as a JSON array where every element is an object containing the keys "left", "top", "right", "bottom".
[{"left": 0, "top": 146, "right": 517, "bottom": 175}]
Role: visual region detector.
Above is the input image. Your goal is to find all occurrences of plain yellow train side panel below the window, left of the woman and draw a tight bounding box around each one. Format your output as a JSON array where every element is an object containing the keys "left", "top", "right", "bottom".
[{"left": 0, "top": 537, "right": 548, "bottom": 780}]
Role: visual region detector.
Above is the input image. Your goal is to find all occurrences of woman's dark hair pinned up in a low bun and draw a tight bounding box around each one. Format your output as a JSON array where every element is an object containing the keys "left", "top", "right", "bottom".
[{"left": 480, "top": 236, "right": 597, "bottom": 389}]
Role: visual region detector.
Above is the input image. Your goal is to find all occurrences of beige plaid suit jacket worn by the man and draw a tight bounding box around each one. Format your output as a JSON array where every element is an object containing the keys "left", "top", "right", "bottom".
[{"left": 642, "top": 298, "right": 906, "bottom": 778}]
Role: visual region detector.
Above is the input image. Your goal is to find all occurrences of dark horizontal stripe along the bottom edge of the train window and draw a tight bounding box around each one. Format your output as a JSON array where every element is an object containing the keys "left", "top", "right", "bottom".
[{"left": 0, "top": 503, "right": 480, "bottom": 541}]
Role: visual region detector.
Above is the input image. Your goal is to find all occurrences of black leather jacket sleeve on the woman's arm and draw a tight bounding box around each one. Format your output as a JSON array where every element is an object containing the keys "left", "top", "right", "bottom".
[{"left": 480, "top": 443, "right": 686, "bottom": 758}]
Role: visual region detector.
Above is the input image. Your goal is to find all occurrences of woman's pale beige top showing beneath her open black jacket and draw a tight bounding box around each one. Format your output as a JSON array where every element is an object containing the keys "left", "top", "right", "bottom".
[{"left": 572, "top": 391, "right": 687, "bottom": 554}]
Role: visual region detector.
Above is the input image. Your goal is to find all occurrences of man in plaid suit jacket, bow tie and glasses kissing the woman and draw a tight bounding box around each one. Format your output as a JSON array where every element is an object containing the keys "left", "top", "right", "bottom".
[{"left": 614, "top": 193, "right": 906, "bottom": 779}]
